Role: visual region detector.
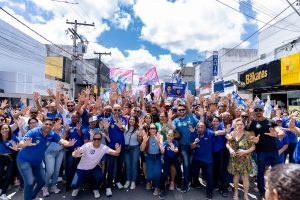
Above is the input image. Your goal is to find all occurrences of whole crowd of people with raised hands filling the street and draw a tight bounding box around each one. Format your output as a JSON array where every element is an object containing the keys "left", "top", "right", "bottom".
[{"left": 0, "top": 86, "right": 300, "bottom": 200}]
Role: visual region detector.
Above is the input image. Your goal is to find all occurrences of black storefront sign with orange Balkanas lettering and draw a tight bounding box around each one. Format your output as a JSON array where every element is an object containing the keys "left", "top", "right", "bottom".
[{"left": 240, "top": 60, "right": 281, "bottom": 89}]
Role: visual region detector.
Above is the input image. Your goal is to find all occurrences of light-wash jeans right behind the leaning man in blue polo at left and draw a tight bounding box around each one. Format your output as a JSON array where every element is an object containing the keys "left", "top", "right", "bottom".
[{"left": 45, "top": 149, "right": 65, "bottom": 187}]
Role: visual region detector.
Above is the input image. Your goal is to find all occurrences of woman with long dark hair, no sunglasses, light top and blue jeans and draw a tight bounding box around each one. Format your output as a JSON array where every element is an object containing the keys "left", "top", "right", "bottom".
[{"left": 124, "top": 116, "right": 140, "bottom": 190}]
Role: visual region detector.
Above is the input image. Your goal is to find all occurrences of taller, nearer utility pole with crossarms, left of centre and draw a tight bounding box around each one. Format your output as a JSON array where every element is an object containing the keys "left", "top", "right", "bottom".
[{"left": 66, "top": 20, "right": 95, "bottom": 99}]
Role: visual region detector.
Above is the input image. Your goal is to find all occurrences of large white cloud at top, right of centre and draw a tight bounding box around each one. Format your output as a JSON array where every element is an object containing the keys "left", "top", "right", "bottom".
[{"left": 134, "top": 0, "right": 246, "bottom": 54}]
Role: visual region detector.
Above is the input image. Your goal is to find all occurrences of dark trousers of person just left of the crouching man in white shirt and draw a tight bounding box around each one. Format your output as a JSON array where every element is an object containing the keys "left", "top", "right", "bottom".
[{"left": 65, "top": 150, "right": 80, "bottom": 187}]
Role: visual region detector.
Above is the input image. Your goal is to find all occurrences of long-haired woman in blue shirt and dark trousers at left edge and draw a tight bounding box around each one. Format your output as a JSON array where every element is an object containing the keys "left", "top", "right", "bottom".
[{"left": 0, "top": 124, "right": 19, "bottom": 200}]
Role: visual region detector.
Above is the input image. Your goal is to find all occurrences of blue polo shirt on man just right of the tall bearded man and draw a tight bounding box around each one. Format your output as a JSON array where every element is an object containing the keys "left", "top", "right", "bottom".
[{"left": 190, "top": 129, "right": 215, "bottom": 163}]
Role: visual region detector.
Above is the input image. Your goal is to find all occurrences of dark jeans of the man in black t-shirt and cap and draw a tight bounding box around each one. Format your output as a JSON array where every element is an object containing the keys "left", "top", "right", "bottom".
[{"left": 257, "top": 151, "right": 280, "bottom": 194}]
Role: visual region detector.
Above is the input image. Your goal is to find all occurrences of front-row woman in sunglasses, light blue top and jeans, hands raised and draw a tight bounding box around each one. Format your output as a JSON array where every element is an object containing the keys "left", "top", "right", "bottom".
[{"left": 140, "top": 123, "right": 164, "bottom": 195}]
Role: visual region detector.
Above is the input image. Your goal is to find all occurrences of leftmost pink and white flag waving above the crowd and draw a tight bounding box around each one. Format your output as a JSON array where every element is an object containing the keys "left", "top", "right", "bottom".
[{"left": 110, "top": 68, "right": 134, "bottom": 84}]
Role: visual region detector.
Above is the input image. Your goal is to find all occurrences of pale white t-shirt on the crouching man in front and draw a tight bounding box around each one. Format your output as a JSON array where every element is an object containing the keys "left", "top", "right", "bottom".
[{"left": 77, "top": 142, "right": 110, "bottom": 170}]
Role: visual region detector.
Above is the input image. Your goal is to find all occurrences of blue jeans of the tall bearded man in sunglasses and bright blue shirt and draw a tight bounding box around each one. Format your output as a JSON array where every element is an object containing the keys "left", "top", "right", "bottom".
[{"left": 180, "top": 145, "right": 191, "bottom": 188}]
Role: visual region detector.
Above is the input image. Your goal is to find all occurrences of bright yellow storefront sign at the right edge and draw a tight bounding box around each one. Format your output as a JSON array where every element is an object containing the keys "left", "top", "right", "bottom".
[{"left": 281, "top": 52, "right": 300, "bottom": 85}]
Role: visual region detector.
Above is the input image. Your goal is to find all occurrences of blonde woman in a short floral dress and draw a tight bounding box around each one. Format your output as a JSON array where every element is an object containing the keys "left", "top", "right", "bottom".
[{"left": 226, "top": 118, "right": 255, "bottom": 200}]
